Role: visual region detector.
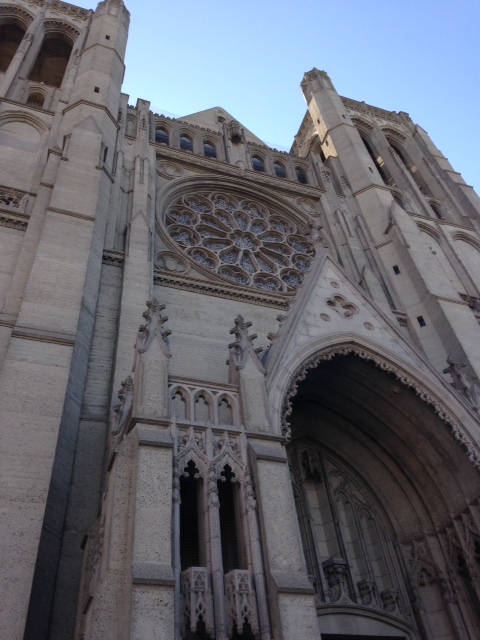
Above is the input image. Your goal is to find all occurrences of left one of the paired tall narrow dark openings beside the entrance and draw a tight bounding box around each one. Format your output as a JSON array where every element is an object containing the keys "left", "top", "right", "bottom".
[{"left": 180, "top": 460, "right": 201, "bottom": 571}]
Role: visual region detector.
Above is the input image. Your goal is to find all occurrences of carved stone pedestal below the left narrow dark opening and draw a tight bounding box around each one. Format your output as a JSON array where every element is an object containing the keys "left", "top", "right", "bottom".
[{"left": 182, "top": 567, "right": 215, "bottom": 638}]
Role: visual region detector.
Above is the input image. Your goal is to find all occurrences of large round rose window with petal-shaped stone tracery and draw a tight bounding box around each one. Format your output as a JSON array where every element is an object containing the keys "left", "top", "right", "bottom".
[{"left": 166, "top": 193, "right": 315, "bottom": 292}]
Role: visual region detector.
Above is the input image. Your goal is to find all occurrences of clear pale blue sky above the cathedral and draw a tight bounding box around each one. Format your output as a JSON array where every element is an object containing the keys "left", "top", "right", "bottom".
[{"left": 77, "top": 0, "right": 480, "bottom": 193}]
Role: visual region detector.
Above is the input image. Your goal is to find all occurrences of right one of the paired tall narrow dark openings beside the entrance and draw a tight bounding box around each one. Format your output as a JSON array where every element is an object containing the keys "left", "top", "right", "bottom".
[{"left": 218, "top": 464, "right": 243, "bottom": 573}]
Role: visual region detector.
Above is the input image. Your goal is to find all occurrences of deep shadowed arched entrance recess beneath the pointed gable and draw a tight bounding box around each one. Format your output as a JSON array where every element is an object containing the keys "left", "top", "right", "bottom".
[{"left": 288, "top": 348, "right": 480, "bottom": 640}]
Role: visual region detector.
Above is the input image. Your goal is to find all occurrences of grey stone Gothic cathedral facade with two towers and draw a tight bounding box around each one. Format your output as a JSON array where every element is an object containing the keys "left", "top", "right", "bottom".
[{"left": 0, "top": 0, "right": 480, "bottom": 640}]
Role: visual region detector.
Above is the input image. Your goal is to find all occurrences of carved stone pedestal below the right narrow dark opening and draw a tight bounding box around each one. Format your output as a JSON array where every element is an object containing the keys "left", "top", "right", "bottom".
[{"left": 225, "top": 569, "right": 260, "bottom": 640}]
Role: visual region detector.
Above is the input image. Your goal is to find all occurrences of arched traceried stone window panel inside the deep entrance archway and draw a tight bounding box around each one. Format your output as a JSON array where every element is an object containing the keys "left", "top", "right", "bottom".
[{"left": 289, "top": 440, "right": 404, "bottom": 609}]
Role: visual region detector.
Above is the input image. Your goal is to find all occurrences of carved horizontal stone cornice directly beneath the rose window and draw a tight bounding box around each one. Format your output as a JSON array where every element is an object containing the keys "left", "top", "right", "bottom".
[{"left": 153, "top": 271, "right": 292, "bottom": 310}]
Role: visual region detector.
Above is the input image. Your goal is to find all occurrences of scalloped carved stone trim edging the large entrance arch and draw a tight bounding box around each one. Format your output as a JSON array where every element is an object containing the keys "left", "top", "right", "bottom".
[{"left": 281, "top": 345, "right": 480, "bottom": 469}]
